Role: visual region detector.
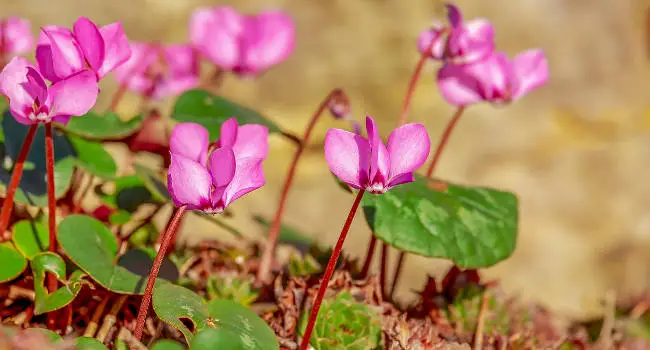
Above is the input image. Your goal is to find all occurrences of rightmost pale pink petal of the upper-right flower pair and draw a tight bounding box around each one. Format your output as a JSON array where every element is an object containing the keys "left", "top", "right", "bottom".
[{"left": 512, "top": 50, "right": 549, "bottom": 100}]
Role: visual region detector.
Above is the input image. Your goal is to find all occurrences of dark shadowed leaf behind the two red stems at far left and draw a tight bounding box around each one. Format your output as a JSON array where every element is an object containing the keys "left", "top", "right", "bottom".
[{"left": 0, "top": 112, "right": 75, "bottom": 207}]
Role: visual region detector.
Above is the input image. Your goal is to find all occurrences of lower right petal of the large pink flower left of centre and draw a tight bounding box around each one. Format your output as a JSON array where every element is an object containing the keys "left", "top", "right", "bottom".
[{"left": 222, "top": 158, "right": 266, "bottom": 208}]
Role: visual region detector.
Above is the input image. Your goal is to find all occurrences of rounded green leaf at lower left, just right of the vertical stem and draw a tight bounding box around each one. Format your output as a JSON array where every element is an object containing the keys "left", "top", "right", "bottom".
[{"left": 58, "top": 215, "right": 160, "bottom": 294}]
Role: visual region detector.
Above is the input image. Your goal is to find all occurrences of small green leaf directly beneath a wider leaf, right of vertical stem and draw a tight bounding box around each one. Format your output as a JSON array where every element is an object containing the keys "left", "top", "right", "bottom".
[{"left": 68, "top": 135, "right": 117, "bottom": 180}]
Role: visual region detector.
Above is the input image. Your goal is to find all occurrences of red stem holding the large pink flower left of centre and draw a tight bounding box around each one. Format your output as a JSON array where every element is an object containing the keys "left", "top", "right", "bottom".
[{"left": 134, "top": 205, "right": 187, "bottom": 340}]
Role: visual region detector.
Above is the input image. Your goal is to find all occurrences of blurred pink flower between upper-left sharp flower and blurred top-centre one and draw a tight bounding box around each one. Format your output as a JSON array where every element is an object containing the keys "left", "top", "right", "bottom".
[{"left": 115, "top": 42, "right": 199, "bottom": 99}]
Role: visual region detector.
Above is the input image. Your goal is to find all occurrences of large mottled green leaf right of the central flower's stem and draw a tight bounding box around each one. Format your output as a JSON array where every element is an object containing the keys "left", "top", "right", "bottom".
[{"left": 362, "top": 176, "right": 518, "bottom": 268}]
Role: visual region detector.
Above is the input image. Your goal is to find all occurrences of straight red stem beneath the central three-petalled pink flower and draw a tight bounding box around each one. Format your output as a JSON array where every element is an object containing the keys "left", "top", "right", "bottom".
[{"left": 300, "top": 190, "right": 365, "bottom": 350}]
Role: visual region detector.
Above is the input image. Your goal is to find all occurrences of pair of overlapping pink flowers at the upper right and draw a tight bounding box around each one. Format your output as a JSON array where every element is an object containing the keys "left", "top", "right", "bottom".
[{"left": 418, "top": 5, "right": 549, "bottom": 106}]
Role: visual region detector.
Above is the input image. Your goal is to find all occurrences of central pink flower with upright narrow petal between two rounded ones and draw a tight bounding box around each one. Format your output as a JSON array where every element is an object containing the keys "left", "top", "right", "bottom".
[{"left": 325, "top": 116, "right": 431, "bottom": 193}]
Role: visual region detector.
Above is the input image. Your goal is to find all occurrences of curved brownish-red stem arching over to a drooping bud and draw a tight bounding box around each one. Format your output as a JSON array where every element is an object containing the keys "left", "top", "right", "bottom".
[{"left": 257, "top": 89, "right": 342, "bottom": 282}]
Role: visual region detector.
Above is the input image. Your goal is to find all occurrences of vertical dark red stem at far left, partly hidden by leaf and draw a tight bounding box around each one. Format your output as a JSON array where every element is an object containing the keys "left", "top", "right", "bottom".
[{"left": 45, "top": 122, "right": 58, "bottom": 329}]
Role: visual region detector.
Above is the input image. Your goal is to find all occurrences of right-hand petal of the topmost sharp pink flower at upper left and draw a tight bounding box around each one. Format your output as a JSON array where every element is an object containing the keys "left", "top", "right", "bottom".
[{"left": 97, "top": 22, "right": 131, "bottom": 78}]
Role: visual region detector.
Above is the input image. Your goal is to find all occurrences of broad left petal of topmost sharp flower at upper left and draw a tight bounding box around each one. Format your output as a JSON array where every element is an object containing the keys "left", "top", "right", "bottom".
[{"left": 43, "top": 29, "right": 85, "bottom": 79}]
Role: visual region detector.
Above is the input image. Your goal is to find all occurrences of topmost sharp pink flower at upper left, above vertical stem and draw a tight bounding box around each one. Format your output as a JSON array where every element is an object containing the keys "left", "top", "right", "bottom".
[{"left": 36, "top": 17, "right": 131, "bottom": 82}]
